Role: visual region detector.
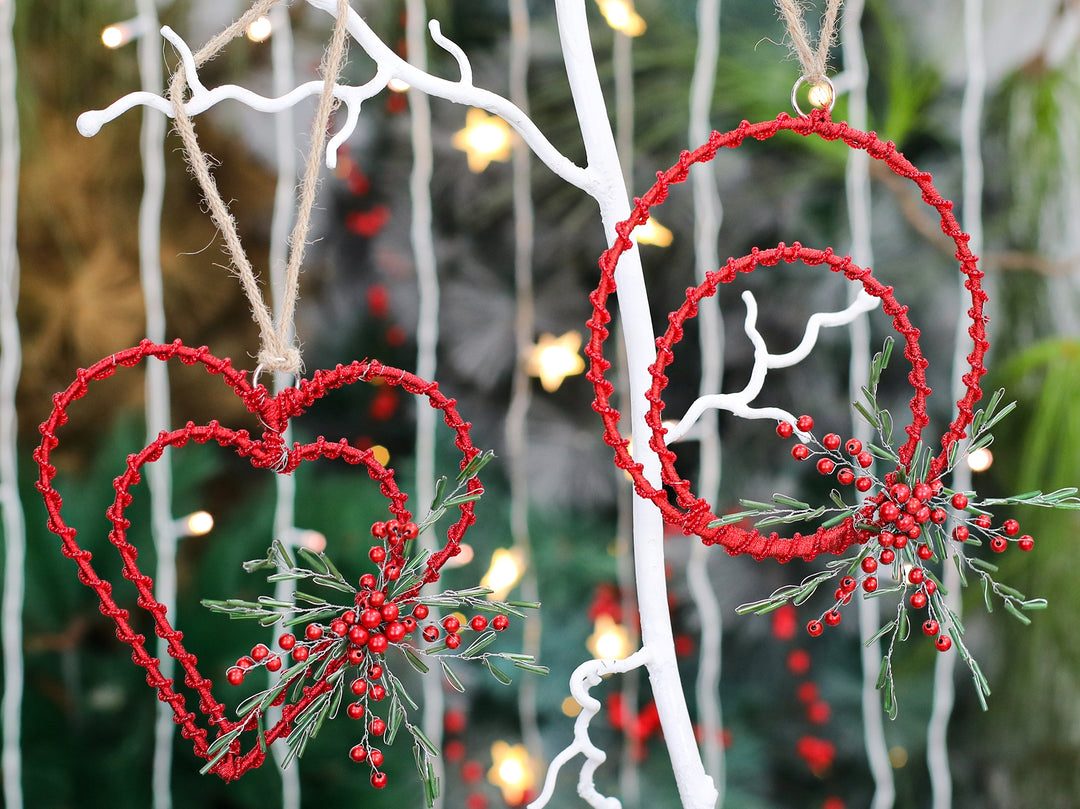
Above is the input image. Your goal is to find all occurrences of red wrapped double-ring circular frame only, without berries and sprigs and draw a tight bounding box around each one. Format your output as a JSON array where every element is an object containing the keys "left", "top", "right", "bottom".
[{"left": 585, "top": 110, "right": 989, "bottom": 562}]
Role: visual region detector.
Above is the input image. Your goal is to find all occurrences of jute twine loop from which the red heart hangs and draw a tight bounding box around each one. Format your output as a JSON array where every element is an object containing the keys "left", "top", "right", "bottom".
[{"left": 168, "top": 0, "right": 349, "bottom": 374}]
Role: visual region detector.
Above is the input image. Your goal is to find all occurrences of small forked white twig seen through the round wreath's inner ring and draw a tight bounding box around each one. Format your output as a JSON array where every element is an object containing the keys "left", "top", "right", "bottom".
[{"left": 665, "top": 289, "right": 880, "bottom": 446}]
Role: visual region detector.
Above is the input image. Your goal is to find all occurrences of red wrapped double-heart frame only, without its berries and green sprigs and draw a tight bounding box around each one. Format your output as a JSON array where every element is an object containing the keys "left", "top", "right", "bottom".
[{"left": 33, "top": 340, "right": 481, "bottom": 781}]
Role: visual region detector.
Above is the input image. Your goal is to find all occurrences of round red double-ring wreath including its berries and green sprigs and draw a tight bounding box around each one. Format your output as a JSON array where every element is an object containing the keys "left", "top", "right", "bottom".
[{"left": 585, "top": 107, "right": 1080, "bottom": 716}]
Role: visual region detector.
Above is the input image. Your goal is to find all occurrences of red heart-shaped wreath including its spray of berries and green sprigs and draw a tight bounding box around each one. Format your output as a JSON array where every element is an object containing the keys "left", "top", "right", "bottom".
[{"left": 33, "top": 340, "right": 546, "bottom": 804}]
